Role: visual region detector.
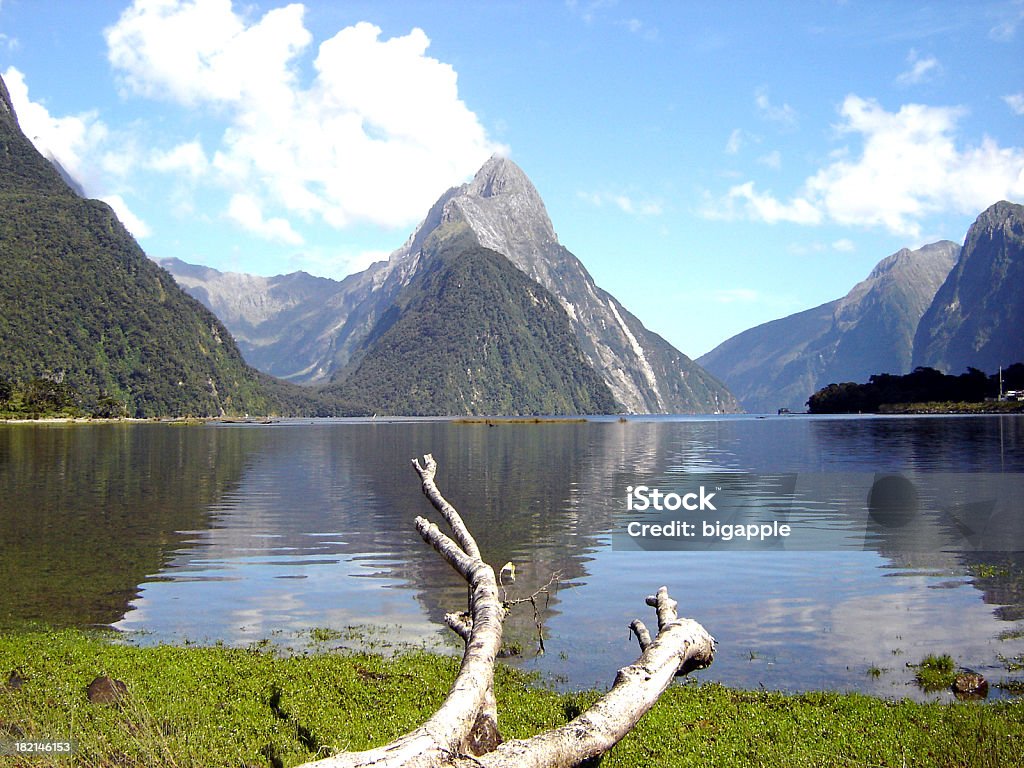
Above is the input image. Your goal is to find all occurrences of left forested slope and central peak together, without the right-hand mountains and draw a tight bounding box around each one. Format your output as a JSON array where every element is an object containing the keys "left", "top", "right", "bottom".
[{"left": 0, "top": 65, "right": 737, "bottom": 417}]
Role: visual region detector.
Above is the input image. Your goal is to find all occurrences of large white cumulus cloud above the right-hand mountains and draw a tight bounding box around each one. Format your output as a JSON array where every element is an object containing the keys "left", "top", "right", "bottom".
[{"left": 703, "top": 94, "right": 1024, "bottom": 238}]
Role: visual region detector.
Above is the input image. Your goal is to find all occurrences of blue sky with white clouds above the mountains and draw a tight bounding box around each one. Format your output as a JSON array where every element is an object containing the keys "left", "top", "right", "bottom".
[{"left": 0, "top": 0, "right": 1024, "bottom": 356}]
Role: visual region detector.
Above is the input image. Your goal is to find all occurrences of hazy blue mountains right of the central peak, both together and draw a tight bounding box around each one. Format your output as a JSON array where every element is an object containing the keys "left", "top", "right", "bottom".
[{"left": 697, "top": 202, "right": 1024, "bottom": 413}]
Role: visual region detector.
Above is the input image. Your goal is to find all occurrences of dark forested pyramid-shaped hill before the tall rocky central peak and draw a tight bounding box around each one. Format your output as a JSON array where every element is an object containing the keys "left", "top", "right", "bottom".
[{"left": 327, "top": 225, "right": 615, "bottom": 416}]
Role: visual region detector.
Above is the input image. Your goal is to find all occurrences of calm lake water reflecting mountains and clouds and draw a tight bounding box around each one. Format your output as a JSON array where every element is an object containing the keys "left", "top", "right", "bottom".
[{"left": 0, "top": 417, "right": 1024, "bottom": 696}]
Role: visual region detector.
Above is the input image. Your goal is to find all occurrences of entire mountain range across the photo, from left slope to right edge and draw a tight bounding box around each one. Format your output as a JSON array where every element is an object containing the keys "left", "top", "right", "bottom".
[{"left": 6, "top": 59, "right": 1024, "bottom": 416}]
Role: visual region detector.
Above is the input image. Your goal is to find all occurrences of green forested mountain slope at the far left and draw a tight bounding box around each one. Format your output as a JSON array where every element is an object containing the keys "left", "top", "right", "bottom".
[{"left": 0, "top": 71, "right": 319, "bottom": 417}]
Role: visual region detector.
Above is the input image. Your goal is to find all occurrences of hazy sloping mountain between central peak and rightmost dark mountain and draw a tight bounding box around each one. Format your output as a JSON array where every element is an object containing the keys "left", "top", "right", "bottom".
[{"left": 697, "top": 241, "right": 959, "bottom": 413}]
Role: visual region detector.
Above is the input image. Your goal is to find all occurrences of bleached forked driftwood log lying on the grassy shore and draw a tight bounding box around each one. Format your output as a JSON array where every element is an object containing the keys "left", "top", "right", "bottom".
[{"left": 300, "top": 454, "right": 715, "bottom": 768}]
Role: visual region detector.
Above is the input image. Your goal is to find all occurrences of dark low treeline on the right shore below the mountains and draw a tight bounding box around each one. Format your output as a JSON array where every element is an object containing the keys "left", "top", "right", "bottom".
[{"left": 807, "top": 362, "right": 1024, "bottom": 414}]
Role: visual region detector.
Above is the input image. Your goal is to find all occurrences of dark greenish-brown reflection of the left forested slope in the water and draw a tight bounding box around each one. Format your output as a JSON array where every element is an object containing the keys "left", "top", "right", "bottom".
[{"left": 0, "top": 425, "right": 248, "bottom": 628}]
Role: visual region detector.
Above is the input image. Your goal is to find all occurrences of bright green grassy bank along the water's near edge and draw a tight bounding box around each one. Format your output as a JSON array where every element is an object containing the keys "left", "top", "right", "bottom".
[{"left": 0, "top": 631, "right": 1024, "bottom": 768}]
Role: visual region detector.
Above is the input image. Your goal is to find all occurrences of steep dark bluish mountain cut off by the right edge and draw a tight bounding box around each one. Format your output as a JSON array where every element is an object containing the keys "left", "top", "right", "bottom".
[{"left": 913, "top": 201, "right": 1024, "bottom": 374}]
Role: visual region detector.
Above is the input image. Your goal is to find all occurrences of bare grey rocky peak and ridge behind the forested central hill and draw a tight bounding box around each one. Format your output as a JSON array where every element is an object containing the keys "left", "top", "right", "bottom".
[{"left": 165, "top": 157, "right": 739, "bottom": 413}]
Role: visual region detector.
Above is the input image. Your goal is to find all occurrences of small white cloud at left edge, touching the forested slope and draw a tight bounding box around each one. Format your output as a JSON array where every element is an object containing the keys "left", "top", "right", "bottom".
[{"left": 3, "top": 67, "right": 108, "bottom": 194}]
